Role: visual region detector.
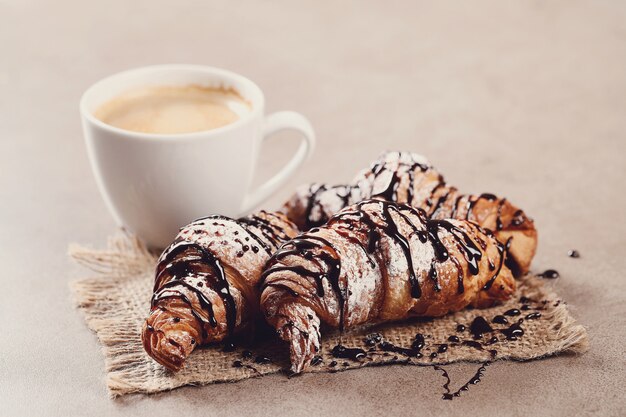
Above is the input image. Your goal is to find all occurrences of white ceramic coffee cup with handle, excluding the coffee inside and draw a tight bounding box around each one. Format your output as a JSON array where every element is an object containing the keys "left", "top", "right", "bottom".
[{"left": 80, "top": 65, "right": 315, "bottom": 248}]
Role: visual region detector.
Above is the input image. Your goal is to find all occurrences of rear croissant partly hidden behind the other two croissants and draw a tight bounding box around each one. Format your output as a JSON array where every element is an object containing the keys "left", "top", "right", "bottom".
[{"left": 283, "top": 152, "right": 537, "bottom": 275}]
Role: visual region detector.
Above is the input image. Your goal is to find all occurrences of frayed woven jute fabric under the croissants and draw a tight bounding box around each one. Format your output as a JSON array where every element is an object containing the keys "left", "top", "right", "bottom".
[{"left": 69, "top": 234, "right": 588, "bottom": 397}]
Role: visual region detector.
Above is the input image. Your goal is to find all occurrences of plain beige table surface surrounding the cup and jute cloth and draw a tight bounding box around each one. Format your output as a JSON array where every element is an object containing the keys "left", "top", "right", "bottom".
[{"left": 0, "top": 0, "right": 626, "bottom": 417}]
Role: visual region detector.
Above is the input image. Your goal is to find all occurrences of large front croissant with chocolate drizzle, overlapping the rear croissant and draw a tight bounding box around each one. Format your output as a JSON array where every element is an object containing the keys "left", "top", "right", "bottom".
[{"left": 261, "top": 199, "right": 516, "bottom": 373}]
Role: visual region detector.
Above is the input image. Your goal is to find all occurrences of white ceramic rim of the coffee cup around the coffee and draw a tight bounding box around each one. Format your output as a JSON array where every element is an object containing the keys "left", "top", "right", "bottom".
[{"left": 79, "top": 64, "right": 265, "bottom": 141}]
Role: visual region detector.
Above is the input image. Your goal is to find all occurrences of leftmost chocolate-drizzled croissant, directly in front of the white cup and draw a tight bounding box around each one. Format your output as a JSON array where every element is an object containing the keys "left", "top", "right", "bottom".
[{"left": 141, "top": 211, "right": 298, "bottom": 371}]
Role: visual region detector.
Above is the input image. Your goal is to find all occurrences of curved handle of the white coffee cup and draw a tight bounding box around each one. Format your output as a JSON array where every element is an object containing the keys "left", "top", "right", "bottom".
[{"left": 241, "top": 111, "right": 315, "bottom": 213}]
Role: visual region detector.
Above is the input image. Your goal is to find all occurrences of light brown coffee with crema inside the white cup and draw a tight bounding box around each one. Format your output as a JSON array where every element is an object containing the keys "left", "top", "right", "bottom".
[{"left": 94, "top": 85, "right": 252, "bottom": 134}]
